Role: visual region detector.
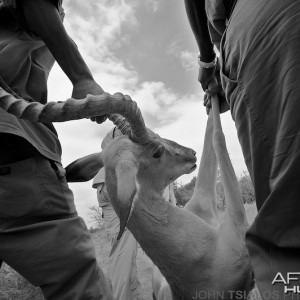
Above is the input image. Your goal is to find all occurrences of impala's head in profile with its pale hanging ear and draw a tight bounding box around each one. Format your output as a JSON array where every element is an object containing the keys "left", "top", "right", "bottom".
[{"left": 98, "top": 95, "right": 196, "bottom": 237}]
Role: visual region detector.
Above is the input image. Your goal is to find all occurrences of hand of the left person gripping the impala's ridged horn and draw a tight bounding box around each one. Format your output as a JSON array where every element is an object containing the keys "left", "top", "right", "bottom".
[{"left": 72, "top": 79, "right": 107, "bottom": 124}]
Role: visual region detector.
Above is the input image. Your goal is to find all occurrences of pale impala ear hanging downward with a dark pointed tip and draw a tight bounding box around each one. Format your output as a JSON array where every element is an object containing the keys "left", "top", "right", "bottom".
[{"left": 115, "top": 161, "right": 137, "bottom": 240}]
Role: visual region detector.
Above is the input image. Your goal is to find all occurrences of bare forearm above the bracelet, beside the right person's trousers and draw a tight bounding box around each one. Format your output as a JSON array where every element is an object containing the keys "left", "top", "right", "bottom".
[{"left": 184, "top": 0, "right": 215, "bottom": 62}]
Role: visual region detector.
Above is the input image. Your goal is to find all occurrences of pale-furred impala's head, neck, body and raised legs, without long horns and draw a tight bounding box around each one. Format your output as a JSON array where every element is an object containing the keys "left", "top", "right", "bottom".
[{"left": 61, "top": 88, "right": 253, "bottom": 300}]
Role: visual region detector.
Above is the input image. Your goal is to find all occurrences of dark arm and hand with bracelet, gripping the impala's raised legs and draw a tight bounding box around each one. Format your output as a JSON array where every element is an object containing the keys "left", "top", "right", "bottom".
[{"left": 185, "top": 0, "right": 216, "bottom": 91}]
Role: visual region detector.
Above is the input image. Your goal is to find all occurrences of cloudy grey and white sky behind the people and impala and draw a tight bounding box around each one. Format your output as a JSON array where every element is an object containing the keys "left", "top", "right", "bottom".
[{"left": 49, "top": 0, "right": 246, "bottom": 226}]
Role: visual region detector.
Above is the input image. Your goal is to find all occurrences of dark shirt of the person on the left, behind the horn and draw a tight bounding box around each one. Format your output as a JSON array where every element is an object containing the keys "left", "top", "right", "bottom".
[{"left": 0, "top": 0, "right": 64, "bottom": 162}]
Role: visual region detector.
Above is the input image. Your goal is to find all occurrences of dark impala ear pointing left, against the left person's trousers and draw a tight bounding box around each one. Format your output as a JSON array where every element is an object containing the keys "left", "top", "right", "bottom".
[{"left": 66, "top": 152, "right": 103, "bottom": 182}]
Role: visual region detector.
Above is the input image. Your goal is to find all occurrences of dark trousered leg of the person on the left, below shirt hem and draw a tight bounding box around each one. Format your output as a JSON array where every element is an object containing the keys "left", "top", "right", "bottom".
[{"left": 0, "top": 154, "right": 112, "bottom": 300}]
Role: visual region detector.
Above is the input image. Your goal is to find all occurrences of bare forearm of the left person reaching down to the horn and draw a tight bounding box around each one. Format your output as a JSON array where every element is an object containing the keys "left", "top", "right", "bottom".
[{"left": 20, "top": 0, "right": 93, "bottom": 85}]
